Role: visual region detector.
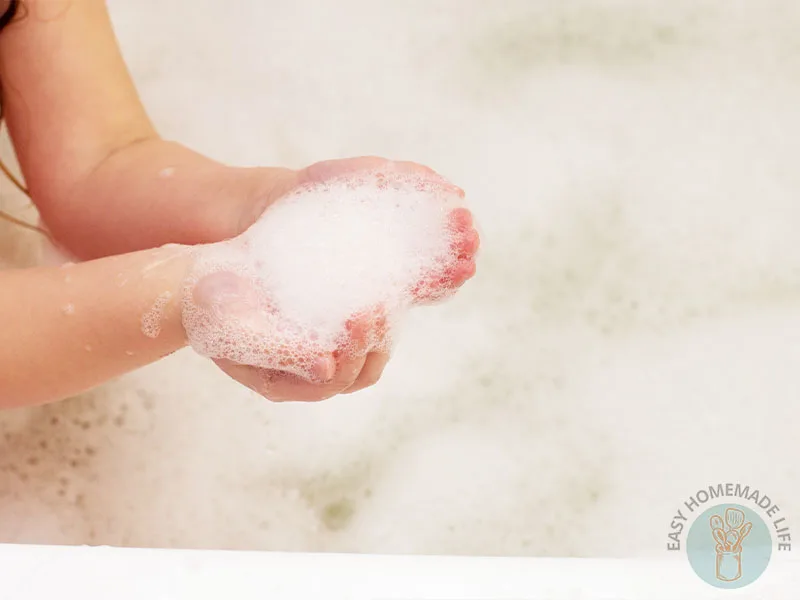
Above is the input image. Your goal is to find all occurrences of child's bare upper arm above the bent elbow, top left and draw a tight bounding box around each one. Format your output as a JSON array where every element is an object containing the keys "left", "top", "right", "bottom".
[{"left": 0, "top": 0, "right": 155, "bottom": 188}]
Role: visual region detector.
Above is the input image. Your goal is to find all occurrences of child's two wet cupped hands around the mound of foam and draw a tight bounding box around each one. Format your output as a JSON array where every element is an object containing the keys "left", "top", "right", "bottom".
[{"left": 187, "top": 157, "right": 479, "bottom": 402}]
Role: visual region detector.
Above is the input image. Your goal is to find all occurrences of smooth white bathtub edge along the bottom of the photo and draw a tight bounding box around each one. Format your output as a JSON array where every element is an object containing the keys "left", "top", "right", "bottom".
[{"left": 0, "top": 545, "right": 800, "bottom": 600}]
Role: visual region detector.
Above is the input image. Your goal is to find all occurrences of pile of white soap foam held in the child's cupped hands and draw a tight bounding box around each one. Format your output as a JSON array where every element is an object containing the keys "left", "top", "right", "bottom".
[{"left": 184, "top": 174, "right": 461, "bottom": 377}]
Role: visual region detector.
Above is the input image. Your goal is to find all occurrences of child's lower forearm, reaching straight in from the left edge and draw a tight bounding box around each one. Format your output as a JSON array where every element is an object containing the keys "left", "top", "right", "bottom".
[{"left": 0, "top": 246, "right": 190, "bottom": 408}]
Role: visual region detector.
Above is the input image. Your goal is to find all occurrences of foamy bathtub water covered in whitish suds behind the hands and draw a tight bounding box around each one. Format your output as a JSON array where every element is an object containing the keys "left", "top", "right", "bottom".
[{"left": 0, "top": 0, "right": 800, "bottom": 572}]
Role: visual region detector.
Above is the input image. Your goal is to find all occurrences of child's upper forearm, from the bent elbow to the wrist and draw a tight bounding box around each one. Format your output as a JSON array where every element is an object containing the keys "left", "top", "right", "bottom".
[{"left": 43, "top": 140, "right": 282, "bottom": 260}]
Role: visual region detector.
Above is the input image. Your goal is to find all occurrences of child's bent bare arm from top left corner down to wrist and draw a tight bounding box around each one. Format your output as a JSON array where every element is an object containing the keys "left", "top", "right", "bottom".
[{"left": 0, "top": 0, "right": 280, "bottom": 259}]
